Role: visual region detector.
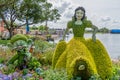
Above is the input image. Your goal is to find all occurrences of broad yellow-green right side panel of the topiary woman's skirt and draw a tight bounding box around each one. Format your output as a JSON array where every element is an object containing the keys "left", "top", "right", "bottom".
[{"left": 86, "top": 39, "right": 112, "bottom": 80}]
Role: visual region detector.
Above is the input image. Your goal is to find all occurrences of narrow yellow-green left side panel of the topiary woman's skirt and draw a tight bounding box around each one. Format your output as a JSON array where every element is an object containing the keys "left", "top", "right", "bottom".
[{"left": 52, "top": 41, "right": 67, "bottom": 68}]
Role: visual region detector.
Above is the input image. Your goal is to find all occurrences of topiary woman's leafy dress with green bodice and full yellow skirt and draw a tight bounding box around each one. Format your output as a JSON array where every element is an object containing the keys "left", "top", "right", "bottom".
[{"left": 52, "top": 19, "right": 112, "bottom": 80}]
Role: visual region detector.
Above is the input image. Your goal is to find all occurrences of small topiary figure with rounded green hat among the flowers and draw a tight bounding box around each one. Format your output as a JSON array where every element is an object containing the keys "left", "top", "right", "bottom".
[{"left": 7, "top": 34, "right": 40, "bottom": 70}]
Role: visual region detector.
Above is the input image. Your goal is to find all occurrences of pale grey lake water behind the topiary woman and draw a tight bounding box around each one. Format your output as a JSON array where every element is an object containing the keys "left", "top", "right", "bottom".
[{"left": 56, "top": 34, "right": 120, "bottom": 59}]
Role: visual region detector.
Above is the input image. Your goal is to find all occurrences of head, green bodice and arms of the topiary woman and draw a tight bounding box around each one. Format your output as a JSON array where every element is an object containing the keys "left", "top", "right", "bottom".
[{"left": 63, "top": 7, "right": 98, "bottom": 42}]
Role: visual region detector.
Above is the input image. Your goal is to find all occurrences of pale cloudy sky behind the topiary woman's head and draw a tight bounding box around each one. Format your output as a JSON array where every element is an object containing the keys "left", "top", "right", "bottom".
[{"left": 48, "top": 0, "right": 120, "bottom": 29}]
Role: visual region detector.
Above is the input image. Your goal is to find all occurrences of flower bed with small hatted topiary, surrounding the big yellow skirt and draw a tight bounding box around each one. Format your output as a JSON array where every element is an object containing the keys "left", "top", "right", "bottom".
[{"left": 0, "top": 34, "right": 120, "bottom": 80}]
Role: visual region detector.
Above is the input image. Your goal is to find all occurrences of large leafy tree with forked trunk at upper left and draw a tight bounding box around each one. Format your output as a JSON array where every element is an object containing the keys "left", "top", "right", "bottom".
[{"left": 0, "top": 0, "right": 60, "bottom": 37}]
